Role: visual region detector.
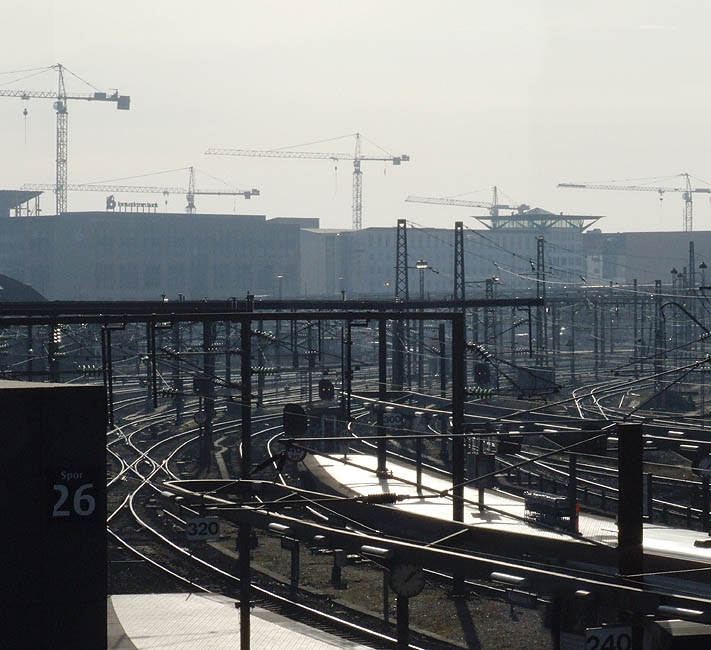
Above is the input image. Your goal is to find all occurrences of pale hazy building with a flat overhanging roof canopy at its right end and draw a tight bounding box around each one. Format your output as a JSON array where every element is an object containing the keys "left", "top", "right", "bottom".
[{"left": 301, "top": 209, "right": 589, "bottom": 298}]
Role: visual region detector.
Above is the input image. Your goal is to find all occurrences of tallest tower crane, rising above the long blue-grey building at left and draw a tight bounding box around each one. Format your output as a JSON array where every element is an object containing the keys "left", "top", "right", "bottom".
[{"left": 0, "top": 63, "right": 131, "bottom": 214}]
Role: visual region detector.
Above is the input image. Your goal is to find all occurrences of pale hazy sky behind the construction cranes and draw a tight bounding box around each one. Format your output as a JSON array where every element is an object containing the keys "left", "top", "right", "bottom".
[{"left": 0, "top": 0, "right": 711, "bottom": 231}]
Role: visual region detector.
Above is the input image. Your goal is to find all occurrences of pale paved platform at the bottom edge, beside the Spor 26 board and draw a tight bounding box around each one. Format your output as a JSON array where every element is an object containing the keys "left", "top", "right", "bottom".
[{"left": 107, "top": 593, "right": 376, "bottom": 650}]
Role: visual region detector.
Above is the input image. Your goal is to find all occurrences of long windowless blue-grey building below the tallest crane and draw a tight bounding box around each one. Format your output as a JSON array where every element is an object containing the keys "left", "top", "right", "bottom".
[{"left": 0, "top": 212, "right": 301, "bottom": 300}]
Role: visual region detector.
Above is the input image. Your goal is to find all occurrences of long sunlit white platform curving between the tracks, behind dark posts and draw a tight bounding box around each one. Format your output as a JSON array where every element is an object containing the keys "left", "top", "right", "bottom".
[{"left": 307, "top": 454, "right": 711, "bottom": 563}]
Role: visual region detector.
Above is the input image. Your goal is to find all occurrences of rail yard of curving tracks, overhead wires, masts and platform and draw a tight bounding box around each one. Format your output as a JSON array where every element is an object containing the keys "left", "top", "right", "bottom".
[{"left": 0, "top": 290, "right": 711, "bottom": 648}]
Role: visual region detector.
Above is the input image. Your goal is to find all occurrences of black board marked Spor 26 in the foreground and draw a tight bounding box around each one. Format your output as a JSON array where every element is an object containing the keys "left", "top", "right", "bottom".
[{"left": 0, "top": 381, "right": 107, "bottom": 650}]
